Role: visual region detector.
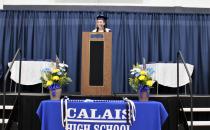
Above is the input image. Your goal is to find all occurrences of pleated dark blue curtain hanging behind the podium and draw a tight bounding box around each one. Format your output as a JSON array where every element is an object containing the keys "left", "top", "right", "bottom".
[{"left": 0, "top": 11, "right": 210, "bottom": 94}]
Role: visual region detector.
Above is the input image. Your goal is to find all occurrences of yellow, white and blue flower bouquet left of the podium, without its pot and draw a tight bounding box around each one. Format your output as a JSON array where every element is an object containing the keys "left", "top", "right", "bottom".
[{"left": 41, "top": 62, "right": 72, "bottom": 91}]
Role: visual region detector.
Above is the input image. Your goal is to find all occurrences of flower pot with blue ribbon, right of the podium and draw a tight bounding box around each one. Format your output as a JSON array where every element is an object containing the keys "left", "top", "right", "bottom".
[{"left": 138, "top": 86, "right": 150, "bottom": 101}]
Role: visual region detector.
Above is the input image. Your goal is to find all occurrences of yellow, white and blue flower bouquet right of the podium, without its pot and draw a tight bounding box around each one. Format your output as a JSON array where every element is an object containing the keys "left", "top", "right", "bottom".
[{"left": 129, "top": 63, "right": 155, "bottom": 92}]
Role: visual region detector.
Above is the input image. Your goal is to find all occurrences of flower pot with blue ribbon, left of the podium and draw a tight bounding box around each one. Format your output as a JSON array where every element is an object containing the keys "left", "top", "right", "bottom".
[{"left": 49, "top": 84, "right": 62, "bottom": 100}]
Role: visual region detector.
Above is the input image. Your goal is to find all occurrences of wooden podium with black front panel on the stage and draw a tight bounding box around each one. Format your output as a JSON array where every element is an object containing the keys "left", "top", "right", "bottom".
[{"left": 81, "top": 32, "right": 112, "bottom": 96}]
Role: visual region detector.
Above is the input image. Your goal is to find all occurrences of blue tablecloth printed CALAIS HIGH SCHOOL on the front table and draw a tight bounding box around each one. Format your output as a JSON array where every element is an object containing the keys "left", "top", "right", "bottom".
[{"left": 37, "top": 100, "right": 168, "bottom": 130}]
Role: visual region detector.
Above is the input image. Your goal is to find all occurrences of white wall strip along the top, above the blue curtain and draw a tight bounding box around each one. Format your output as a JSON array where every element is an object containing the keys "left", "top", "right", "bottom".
[{"left": 2, "top": 0, "right": 210, "bottom": 8}]
